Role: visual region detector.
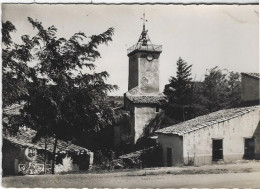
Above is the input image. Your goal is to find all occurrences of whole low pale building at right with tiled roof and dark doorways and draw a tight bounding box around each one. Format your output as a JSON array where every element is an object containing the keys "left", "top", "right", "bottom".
[{"left": 156, "top": 106, "right": 260, "bottom": 166}]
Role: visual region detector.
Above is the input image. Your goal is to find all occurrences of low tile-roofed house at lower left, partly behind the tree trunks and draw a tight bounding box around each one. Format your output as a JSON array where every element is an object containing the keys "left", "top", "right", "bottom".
[{"left": 2, "top": 104, "right": 93, "bottom": 176}]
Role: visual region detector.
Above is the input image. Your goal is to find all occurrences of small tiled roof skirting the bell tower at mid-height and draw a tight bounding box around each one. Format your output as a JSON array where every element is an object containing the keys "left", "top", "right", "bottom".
[{"left": 125, "top": 87, "right": 165, "bottom": 104}]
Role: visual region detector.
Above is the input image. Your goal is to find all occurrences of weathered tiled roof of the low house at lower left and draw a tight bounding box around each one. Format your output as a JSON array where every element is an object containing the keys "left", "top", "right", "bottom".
[{"left": 3, "top": 127, "right": 91, "bottom": 154}]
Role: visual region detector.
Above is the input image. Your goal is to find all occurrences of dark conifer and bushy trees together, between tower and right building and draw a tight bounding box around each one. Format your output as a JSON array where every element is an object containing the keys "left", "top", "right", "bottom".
[{"left": 165, "top": 58, "right": 241, "bottom": 122}]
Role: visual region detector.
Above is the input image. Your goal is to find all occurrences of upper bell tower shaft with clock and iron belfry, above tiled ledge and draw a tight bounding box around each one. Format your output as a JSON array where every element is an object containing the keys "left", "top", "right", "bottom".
[{"left": 127, "top": 14, "right": 162, "bottom": 94}]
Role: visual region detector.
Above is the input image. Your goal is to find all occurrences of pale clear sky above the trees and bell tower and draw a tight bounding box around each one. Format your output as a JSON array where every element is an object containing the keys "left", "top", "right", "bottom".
[{"left": 2, "top": 4, "right": 259, "bottom": 96}]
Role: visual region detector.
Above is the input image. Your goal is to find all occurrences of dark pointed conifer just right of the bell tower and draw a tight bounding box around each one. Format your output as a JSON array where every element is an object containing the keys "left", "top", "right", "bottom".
[{"left": 164, "top": 58, "right": 192, "bottom": 121}]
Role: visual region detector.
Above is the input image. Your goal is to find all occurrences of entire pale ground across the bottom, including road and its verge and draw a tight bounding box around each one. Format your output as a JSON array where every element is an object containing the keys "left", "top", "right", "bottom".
[{"left": 2, "top": 162, "right": 260, "bottom": 188}]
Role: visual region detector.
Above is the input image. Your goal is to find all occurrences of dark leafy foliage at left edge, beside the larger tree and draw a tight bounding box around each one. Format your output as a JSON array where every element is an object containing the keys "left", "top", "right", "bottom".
[{"left": 2, "top": 21, "right": 32, "bottom": 108}]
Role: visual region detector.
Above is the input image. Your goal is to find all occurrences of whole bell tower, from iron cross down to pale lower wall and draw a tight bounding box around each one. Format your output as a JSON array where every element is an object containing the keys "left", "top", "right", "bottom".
[{"left": 124, "top": 14, "right": 164, "bottom": 143}]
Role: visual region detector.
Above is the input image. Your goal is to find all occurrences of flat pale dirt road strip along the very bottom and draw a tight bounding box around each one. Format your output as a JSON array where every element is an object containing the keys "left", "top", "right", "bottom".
[{"left": 2, "top": 172, "right": 260, "bottom": 188}]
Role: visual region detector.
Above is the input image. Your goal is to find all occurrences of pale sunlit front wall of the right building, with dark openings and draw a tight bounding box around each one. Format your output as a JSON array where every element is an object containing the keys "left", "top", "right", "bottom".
[{"left": 183, "top": 108, "right": 260, "bottom": 165}]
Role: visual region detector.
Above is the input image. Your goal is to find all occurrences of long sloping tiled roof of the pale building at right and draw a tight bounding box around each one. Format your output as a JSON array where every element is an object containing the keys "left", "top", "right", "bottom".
[{"left": 155, "top": 106, "right": 260, "bottom": 136}]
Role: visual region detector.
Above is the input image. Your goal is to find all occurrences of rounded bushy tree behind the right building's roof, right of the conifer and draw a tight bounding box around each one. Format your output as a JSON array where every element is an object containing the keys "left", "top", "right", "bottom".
[{"left": 197, "top": 67, "right": 241, "bottom": 112}]
